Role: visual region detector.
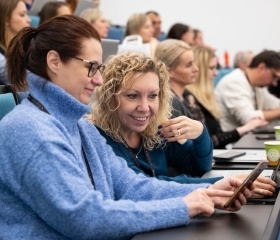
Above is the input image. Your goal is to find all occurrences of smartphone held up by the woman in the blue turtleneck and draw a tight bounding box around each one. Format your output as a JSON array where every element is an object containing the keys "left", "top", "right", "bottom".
[{"left": 224, "top": 161, "right": 268, "bottom": 208}]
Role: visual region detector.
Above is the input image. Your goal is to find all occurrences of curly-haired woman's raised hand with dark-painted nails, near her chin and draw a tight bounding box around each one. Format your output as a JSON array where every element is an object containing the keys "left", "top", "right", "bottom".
[{"left": 159, "top": 116, "right": 203, "bottom": 142}]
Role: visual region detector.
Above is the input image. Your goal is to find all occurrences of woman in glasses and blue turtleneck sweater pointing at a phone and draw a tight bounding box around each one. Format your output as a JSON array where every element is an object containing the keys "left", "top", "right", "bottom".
[{"left": 0, "top": 15, "right": 254, "bottom": 239}]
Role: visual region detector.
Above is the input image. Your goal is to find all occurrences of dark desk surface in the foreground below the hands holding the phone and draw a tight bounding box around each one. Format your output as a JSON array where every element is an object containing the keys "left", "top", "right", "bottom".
[{"left": 133, "top": 205, "right": 273, "bottom": 240}]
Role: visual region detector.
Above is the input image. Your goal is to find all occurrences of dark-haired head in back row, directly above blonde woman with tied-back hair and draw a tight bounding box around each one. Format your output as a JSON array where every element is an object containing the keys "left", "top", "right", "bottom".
[{"left": 167, "top": 23, "right": 194, "bottom": 46}]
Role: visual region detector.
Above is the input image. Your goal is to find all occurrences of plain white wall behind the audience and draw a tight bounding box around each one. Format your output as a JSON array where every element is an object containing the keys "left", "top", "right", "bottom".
[{"left": 100, "top": 0, "right": 280, "bottom": 64}]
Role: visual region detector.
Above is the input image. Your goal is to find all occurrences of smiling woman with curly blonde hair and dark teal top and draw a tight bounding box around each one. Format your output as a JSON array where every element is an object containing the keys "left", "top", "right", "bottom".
[{"left": 90, "top": 53, "right": 220, "bottom": 183}]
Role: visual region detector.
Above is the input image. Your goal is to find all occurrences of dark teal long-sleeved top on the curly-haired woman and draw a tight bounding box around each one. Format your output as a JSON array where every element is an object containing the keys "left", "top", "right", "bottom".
[{"left": 98, "top": 126, "right": 222, "bottom": 183}]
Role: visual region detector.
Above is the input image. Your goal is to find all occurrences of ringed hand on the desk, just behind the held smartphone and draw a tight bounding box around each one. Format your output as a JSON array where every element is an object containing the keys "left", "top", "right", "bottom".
[{"left": 237, "top": 174, "right": 277, "bottom": 198}]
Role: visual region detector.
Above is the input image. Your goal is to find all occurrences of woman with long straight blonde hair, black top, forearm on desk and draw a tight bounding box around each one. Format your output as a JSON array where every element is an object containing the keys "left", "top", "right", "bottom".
[{"left": 185, "top": 46, "right": 267, "bottom": 148}]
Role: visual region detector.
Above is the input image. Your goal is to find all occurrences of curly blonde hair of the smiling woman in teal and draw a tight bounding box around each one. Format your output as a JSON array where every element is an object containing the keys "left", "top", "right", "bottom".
[{"left": 88, "top": 52, "right": 171, "bottom": 150}]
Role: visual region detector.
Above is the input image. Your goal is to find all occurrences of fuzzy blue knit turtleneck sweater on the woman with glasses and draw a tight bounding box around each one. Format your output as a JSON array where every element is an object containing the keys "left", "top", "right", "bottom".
[{"left": 0, "top": 74, "right": 208, "bottom": 240}]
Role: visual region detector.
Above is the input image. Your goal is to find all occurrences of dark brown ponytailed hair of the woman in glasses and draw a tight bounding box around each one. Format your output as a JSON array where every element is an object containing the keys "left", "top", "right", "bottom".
[{"left": 7, "top": 15, "right": 101, "bottom": 89}]
